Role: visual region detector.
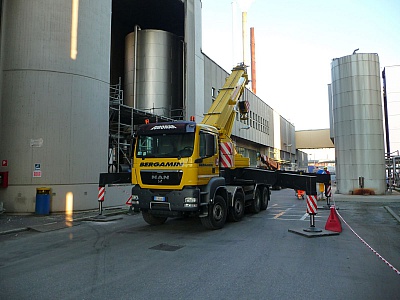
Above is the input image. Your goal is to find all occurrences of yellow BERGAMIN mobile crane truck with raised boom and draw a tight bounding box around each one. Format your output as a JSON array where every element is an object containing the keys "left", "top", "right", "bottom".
[{"left": 100, "top": 64, "right": 324, "bottom": 229}]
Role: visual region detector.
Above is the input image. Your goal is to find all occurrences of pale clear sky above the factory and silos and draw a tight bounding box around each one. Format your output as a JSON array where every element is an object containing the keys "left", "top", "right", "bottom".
[{"left": 202, "top": 0, "right": 400, "bottom": 131}]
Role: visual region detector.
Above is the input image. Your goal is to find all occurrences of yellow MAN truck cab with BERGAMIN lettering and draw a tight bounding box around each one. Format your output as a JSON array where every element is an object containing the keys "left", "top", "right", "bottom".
[{"left": 132, "top": 121, "right": 224, "bottom": 224}]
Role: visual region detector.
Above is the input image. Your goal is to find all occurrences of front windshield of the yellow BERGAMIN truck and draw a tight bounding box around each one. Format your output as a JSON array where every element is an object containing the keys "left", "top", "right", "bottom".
[{"left": 136, "top": 132, "right": 194, "bottom": 158}]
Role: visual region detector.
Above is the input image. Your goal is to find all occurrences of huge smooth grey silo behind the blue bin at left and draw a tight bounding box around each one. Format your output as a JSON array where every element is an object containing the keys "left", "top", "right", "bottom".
[{"left": 0, "top": 0, "right": 111, "bottom": 212}]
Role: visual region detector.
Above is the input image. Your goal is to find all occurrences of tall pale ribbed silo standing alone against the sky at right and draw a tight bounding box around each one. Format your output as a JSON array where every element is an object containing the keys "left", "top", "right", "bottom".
[{"left": 331, "top": 53, "right": 386, "bottom": 194}]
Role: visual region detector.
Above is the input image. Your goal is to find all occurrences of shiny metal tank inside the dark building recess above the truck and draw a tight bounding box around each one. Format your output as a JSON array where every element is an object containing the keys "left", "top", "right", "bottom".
[{"left": 124, "top": 29, "right": 183, "bottom": 117}]
